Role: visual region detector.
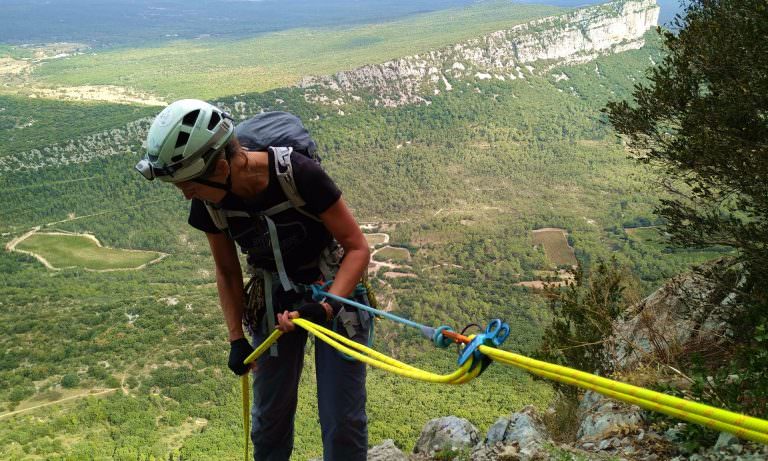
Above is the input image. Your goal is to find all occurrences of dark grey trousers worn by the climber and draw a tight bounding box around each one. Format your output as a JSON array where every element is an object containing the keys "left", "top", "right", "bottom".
[{"left": 251, "top": 296, "right": 372, "bottom": 461}]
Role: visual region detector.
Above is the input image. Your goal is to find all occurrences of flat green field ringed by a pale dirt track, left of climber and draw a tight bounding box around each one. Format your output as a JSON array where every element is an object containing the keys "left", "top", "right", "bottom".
[{"left": 16, "top": 234, "right": 160, "bottom": 270}]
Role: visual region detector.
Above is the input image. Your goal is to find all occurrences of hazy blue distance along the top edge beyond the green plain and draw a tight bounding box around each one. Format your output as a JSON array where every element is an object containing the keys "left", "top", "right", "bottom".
[{"left": 0, "top": 0, "right": 680, "bottom": 47}]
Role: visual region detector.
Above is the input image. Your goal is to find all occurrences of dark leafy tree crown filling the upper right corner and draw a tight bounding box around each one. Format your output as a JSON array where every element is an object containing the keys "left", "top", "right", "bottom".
[{"left": 607, "top": 0, "right": 768, "bottom": 286}]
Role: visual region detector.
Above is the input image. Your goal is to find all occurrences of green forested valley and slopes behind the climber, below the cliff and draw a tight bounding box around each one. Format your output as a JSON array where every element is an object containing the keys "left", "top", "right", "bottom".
[{"left": 0, "top": 1, "right": 728, "bottom": 460}]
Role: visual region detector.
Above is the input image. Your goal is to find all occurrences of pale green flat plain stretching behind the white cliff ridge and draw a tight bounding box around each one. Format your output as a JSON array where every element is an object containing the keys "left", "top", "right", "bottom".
[{"left": 24, "top": 2, "right": 565, "bottom": 99}]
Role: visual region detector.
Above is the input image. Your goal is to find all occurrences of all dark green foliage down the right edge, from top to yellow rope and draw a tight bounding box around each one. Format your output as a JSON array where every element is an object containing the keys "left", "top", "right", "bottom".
[{"left": 606, "top": 0, "right": 768, "bottom": 442}]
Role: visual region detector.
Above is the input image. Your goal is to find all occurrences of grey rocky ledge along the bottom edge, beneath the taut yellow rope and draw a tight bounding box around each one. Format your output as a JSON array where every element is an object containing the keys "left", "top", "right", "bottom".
[{"left": 368, "top": 392, "right": 768, "bottom": 461}]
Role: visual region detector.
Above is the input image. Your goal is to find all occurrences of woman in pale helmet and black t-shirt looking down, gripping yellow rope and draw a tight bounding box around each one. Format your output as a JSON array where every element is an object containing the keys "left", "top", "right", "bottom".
[{"left": 136, "top": 99, "right": 370, "bottom": 461}]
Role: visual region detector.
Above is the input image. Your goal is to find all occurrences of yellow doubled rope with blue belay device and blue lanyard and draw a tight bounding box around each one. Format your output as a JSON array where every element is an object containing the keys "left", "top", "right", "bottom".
[{"left": 241, "top": 285, "right": 768, "bottom": 461}]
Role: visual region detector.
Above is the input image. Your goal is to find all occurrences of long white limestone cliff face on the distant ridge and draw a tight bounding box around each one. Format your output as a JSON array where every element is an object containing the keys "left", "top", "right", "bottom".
[{"left": 299, "top": 0, "right": 659, "bottom": 106}]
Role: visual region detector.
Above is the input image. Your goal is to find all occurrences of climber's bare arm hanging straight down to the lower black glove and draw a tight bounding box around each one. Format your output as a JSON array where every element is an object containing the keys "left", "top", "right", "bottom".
[{"left": 205, "top": 233, "right": 245, "bottom": 342}]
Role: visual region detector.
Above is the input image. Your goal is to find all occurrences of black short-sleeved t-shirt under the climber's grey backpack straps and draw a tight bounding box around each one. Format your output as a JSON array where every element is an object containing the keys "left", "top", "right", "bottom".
[{"left": 189, "top": 152, "right": 341, "bottom": 283}]
